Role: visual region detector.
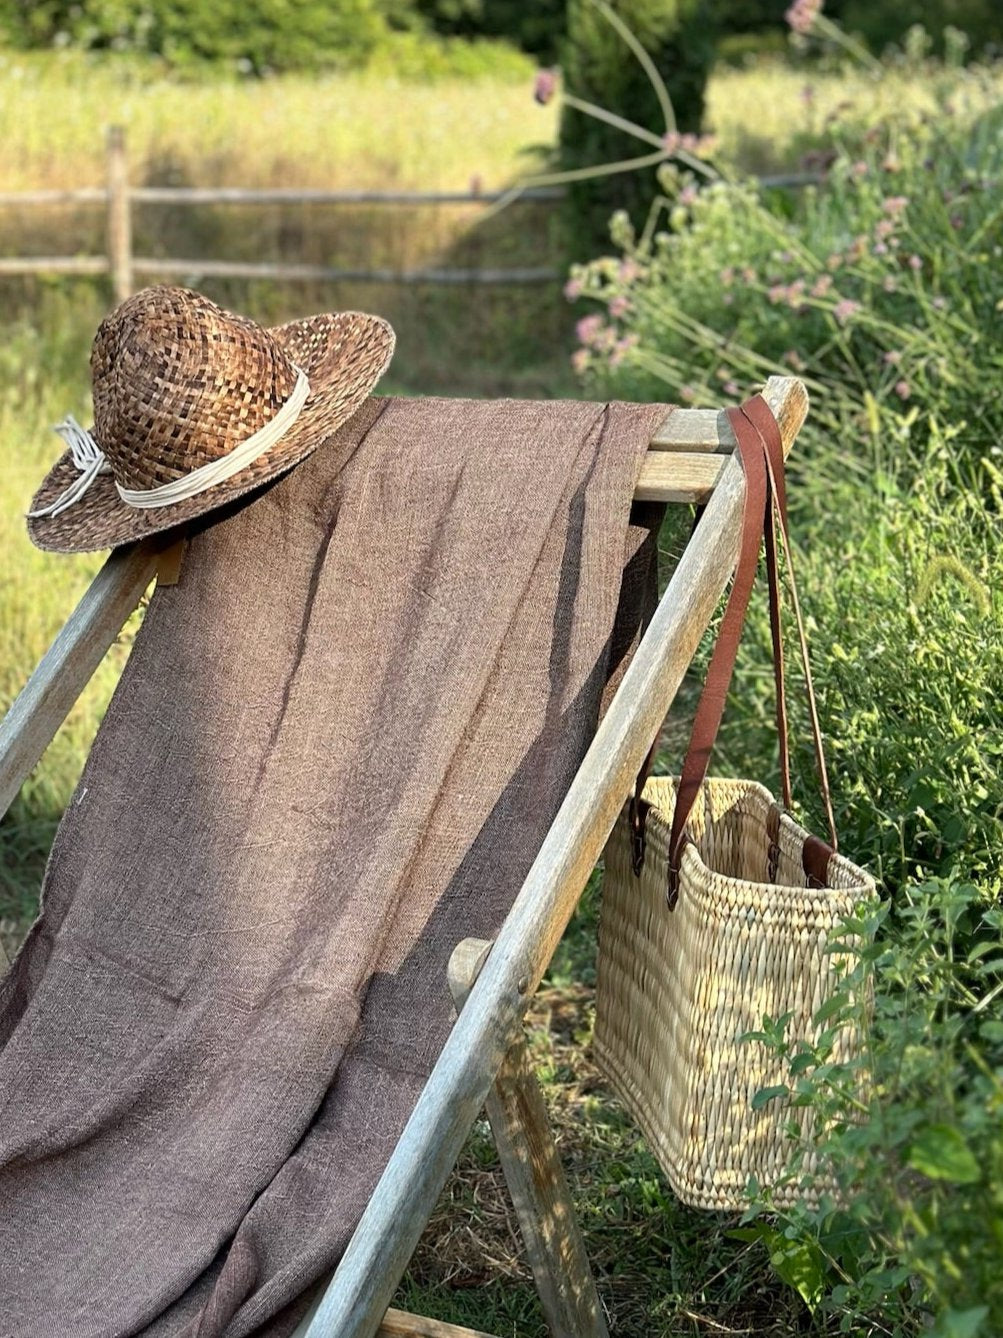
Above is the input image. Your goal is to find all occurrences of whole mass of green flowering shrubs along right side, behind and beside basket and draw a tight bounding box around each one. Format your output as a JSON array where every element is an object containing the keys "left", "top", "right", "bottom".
[{"left": 567, "top": 47, "right": 1003, "bottom": 1338}]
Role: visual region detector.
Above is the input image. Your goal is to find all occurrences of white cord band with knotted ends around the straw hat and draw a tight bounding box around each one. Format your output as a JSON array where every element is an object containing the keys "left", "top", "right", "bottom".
[{"left": 28, "top": 367, "right": 310, "bottom": 516}]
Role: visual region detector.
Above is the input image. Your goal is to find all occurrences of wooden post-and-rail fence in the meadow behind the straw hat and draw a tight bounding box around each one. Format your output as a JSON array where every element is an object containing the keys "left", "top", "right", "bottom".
[{"left": 0, "top": 126, "right": 562, "bottom": 302}]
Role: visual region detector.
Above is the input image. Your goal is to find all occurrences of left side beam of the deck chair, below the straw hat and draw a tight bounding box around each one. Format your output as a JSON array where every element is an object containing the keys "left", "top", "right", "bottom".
[{"left": 0, "top": 541, "right": 159, "bottom": 818}]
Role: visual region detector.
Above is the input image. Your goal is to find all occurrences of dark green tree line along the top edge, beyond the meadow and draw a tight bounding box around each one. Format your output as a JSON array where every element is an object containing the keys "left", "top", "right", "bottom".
[{"left": 0, "top": 0, "right": 1003, "bottom": 74}]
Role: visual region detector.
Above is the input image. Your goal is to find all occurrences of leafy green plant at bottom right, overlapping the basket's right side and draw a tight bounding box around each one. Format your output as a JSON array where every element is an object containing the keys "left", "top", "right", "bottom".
[{"left": 737, "top": 879, "right": 1003, "bottom": 1338}]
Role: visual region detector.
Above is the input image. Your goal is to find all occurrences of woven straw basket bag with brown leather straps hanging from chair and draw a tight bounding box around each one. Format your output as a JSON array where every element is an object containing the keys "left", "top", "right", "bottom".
[{"left": 594, "top": 397, "right": 875, "bottom": 1211}]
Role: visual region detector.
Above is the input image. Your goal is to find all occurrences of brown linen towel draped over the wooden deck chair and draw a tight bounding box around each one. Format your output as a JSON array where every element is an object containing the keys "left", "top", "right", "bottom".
[{"left": 0, "top": 400, "right": 666, "bottom": 1338}]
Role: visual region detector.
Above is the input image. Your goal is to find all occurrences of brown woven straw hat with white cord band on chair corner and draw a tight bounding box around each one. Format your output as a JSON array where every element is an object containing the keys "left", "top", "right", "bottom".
[{"left": 28, "top": 286, "right": 395, "bottom": 553}]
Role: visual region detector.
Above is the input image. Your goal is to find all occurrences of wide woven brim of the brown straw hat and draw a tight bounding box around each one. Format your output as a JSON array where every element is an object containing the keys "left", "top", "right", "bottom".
[{"left": 28, "top": 312, "right": 395, "bottom": 553}]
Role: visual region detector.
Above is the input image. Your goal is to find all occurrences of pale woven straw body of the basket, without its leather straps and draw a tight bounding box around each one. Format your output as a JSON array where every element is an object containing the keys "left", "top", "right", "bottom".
[{"left": 594, "top": 779, "right": 875, "bottom": 1210}]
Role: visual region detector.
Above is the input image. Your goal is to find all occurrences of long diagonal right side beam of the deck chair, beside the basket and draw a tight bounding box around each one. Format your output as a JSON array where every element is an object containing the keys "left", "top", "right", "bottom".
[{"left": 306, "top": 377, "right": 808, "bottom": 1338}]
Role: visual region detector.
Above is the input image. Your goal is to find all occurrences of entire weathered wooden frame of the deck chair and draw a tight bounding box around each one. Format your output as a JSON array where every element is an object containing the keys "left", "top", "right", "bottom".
[{"left": 0, "top": 377, "right": 808, "bottom": 1338}]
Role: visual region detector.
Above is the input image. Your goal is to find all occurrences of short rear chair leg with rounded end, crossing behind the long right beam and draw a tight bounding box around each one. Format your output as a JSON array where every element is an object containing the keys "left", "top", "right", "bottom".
[{"left": 448, "top": 938, "right": 608, "bottom": 1338}]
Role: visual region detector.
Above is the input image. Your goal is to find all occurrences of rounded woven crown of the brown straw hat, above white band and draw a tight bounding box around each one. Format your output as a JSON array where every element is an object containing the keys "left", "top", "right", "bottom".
[{"left": 91, "top": 286, "right": 297, "bottom": 490}]
